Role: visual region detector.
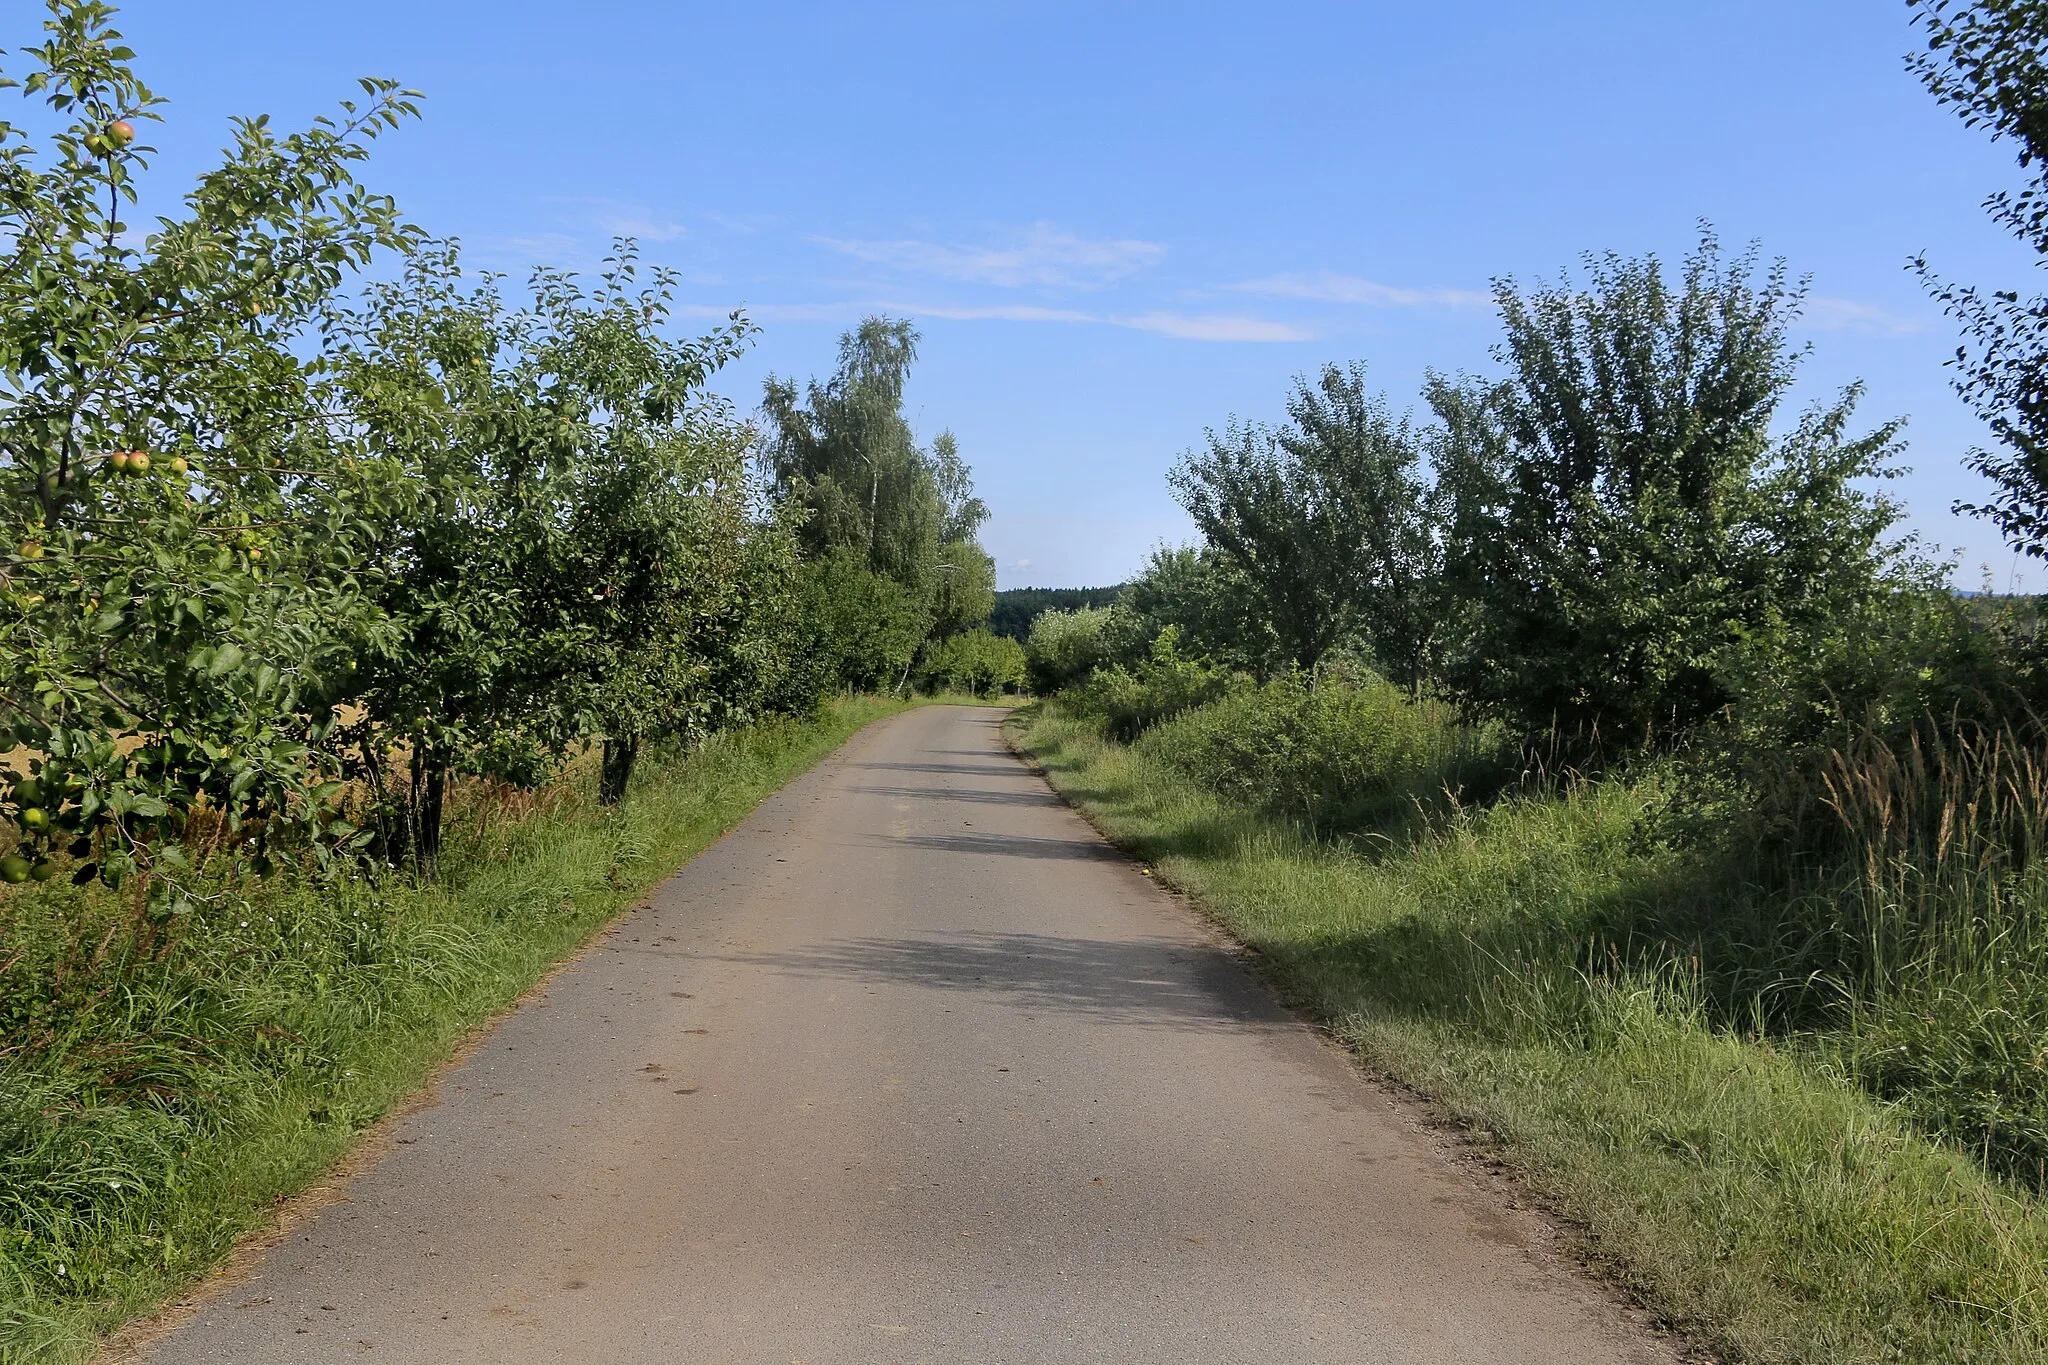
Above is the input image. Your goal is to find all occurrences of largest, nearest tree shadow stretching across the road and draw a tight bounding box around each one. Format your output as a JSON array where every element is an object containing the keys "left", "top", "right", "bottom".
[{"left": 719, "top": 931, "right": 1286, "bottom": 1031}]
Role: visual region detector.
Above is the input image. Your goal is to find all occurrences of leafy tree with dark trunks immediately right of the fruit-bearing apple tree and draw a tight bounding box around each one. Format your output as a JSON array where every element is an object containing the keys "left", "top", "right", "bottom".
[{"left": 328, "top": 246, "right": 552, "bottom": 868}]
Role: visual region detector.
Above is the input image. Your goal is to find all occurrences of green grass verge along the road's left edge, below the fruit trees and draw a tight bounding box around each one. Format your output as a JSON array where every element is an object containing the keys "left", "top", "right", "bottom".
[{"left": 0, "top": 698, "right": 937, "bottom": 1365}]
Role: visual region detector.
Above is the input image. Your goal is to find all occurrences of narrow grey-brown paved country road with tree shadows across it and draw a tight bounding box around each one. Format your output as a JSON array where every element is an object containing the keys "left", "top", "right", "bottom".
[{"left": 128, "top": 708, "right": 1671, "bottom": 1365}]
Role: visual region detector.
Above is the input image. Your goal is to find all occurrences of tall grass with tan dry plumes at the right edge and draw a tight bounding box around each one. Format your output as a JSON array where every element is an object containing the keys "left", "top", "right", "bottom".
[{"left": 1802, "top": 726, "right": 2048, "bottom": 1187}]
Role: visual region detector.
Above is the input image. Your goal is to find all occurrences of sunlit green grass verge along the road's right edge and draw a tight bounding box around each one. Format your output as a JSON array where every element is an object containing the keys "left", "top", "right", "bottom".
[{"left": 1012, "top": 704, "right": 2048, "bottom": 1363}]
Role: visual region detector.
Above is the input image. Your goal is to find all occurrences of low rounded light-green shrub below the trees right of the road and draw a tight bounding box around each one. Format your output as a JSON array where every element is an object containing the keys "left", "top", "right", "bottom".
[{"left": 1139, "top": 673, "right": 1511, "bottom": 829}]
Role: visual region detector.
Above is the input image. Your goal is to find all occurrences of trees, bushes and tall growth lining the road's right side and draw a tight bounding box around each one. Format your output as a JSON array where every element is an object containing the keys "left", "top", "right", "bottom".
[{"left": 1028, "top": 4, "right": 2048, "bottom": 1183}]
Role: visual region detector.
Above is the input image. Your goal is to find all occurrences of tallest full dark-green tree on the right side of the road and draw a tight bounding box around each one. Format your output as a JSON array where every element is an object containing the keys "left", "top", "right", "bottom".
[{"left": 1432, "top": 235, "right": 1903, "bottom": 743}]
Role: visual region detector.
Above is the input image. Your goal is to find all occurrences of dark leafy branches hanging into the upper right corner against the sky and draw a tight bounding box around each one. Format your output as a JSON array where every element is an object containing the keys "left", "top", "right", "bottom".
[{"left": 1907, "top": 0, "right": 2048, "bottom": 559}]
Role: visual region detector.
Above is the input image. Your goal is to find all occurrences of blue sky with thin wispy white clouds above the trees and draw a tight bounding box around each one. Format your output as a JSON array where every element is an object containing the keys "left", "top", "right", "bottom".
[{"left": 79, "top": 0, "right": 2048, "bottom": 587}]
